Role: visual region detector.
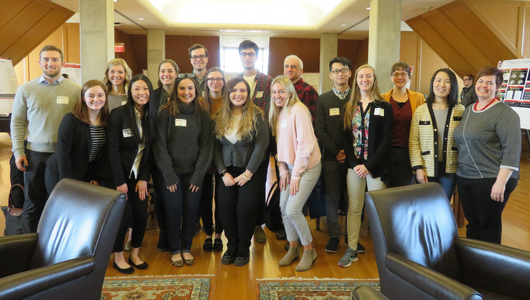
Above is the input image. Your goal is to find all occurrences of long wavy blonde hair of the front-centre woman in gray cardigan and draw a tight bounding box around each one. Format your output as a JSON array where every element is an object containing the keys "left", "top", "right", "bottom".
[{"left": 212, "top": 77, "right": 264, "bottom": 140}]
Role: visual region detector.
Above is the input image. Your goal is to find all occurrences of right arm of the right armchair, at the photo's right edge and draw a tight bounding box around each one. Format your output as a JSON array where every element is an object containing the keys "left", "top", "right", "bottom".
[{"left": 455, "top": 238, "right": 530, "bottom": 299}]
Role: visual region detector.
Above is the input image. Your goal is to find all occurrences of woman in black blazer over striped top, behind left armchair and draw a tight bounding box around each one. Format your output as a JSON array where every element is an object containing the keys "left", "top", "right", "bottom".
[{"left": 46, "top": 80, "right": 109, "bottom": 193}]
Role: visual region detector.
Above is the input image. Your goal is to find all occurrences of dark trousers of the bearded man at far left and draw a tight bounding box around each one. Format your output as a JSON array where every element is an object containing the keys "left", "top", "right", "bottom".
[{"left": 20, "top": 148, "right": 53, "bottom": 233}]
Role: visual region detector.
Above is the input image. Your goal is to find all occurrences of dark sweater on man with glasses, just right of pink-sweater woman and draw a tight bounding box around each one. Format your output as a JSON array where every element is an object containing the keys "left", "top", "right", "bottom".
[{"left": 315, "top": 89, "right": 351, "bottom": 161}]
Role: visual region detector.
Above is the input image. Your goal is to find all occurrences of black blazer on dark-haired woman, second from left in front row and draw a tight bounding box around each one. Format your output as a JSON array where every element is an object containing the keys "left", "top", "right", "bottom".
[{"left": 107, "top": 103, "right": 152, "bottom": 186}]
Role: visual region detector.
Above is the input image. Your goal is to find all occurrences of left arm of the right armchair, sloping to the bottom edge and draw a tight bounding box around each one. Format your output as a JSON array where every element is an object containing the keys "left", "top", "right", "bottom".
[{"left": 385, "top": 253, "right": 482, "bottom": 300}]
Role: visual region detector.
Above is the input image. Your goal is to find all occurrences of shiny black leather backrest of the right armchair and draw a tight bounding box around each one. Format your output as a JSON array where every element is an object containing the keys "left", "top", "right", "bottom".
[{"left": 366, "top": 183, "right": 461, "bottom": 282}]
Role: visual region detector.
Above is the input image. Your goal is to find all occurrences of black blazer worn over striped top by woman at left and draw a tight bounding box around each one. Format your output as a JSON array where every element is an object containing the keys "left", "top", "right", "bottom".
[{"left": 46, "top": 113, "right": 98, "bottom": 180}]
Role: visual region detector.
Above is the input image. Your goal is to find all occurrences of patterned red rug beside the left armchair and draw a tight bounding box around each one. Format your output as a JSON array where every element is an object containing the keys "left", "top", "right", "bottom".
[{"left": 100, "top": 276, "right": 210, "bottom": 300}]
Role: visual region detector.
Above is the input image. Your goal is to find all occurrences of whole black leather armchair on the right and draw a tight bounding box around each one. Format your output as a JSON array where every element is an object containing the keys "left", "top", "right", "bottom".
[{"left": 366, "top": 183, "right": 530, "bottom": 300}]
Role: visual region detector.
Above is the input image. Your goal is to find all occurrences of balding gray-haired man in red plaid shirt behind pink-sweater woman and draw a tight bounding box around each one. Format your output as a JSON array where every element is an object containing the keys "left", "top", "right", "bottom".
[{"left": 283, "top": 55, "right": 318, "bottom": 121}]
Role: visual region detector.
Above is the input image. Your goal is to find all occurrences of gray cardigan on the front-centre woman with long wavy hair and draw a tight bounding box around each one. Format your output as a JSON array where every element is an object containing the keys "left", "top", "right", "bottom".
[{"left": 214, "top": 113, "right": 269, "bottom": 173}]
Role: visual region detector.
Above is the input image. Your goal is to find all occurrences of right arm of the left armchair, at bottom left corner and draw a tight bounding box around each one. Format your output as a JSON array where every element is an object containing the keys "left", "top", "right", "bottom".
[{"left": 0, "top": 256, "right": 95, "bottom": 300}]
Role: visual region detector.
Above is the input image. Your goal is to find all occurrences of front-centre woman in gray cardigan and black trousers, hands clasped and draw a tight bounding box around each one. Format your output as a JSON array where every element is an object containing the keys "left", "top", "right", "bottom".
[{"left": 212, "top": 77, "right": 269, "bottom": 266}]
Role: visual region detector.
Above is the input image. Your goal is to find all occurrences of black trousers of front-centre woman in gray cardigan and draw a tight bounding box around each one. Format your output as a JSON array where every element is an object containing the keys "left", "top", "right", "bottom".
[{"left": 216, "top": 160, "right": 269, "bottom": 250}]
